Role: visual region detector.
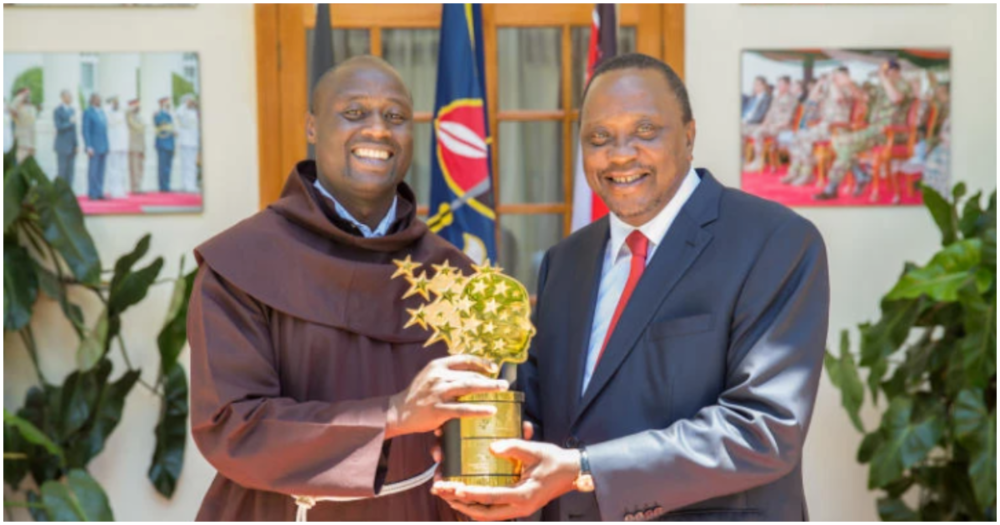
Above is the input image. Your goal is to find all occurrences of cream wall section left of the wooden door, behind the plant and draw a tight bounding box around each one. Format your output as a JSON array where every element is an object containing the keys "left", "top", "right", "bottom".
[{"left": 2, "top": 2, "right": 259, "bottom": 523}]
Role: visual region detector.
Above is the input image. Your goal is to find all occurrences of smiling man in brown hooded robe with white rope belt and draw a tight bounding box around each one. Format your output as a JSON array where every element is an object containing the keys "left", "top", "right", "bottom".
[{"left": 188, "top": 57, "right": 508, "bottom": 523}]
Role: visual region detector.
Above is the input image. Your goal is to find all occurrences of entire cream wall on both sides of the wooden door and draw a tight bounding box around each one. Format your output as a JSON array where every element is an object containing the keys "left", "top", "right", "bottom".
[{"left": 2, "top": 2, "right": 998, "bottom": 522}]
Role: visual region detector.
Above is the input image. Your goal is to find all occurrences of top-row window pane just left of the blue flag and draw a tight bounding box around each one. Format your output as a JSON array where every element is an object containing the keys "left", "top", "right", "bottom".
[{"left": 382, "top": 29, "right": 440, "bottom": 112}]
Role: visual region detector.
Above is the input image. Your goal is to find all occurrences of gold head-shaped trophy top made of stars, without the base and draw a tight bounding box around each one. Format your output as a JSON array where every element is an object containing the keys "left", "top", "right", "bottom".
[{"left": 392, "top": 257, "right": 535, "bottom": 368}]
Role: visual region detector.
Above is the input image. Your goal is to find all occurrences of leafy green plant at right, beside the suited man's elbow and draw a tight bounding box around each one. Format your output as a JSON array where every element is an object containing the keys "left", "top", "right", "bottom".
[{"left": 826, "top": 185, "right": 997, "bottom": 523}]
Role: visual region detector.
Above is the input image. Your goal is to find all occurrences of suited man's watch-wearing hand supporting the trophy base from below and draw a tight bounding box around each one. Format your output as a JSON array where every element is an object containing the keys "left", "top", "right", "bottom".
[{"left": 432, "top": 441, "right": 580, "bottom": 523}]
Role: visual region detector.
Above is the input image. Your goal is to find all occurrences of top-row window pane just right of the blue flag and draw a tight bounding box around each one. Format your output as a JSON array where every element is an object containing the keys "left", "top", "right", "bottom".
[{"left": 497, "top": 28, "right": 562, "bottom": 111}]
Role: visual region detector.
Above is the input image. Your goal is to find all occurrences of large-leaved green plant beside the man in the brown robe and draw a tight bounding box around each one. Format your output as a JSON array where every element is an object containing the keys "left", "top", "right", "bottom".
[{"left": 2, "top": 149, "right": 194, "bottom": 523}]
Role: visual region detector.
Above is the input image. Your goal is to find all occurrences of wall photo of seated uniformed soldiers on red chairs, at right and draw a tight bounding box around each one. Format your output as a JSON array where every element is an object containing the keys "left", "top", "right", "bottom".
[{"left": 739, "top": 48, "right": 952, "bottom": 207}]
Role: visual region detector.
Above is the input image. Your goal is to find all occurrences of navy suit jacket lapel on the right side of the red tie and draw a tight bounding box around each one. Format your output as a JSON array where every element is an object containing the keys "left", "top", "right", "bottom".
[{"left": 572, "top": 171, "right": 722, "bottom": 424}]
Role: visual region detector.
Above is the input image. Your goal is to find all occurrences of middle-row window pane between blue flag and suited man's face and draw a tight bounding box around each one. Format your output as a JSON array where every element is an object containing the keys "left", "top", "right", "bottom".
[{"left": 499, "top": 122, "right": 565, "bottom": 204}]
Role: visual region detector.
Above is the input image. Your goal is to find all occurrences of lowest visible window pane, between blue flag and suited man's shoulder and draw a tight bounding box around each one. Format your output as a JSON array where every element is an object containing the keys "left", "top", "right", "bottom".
[{"left": 500, "top": 215, "right": 563, "bottom": 295}]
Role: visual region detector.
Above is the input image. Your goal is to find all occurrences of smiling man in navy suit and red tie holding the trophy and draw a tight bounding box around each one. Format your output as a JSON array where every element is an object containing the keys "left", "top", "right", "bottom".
[{"left": 435, "top": 55, "right": 829, "bottom": 523}]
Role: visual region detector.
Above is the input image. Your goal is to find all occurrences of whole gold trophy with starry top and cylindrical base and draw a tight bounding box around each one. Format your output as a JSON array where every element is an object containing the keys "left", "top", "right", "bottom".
[{"left": 392, "top": 257, "right": 535, "bottom": 487}]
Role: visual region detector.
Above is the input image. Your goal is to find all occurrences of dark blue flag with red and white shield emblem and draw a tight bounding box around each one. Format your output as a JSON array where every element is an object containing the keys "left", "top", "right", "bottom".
[{"left": 427, "top": 2, "right": 497, "bottom": 264}]
